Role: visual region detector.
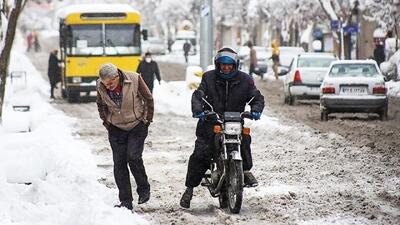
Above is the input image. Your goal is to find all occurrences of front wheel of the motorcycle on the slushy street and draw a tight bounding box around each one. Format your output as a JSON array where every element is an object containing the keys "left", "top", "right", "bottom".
[{"left": 228, "top": 159, "right": 243, "bottom": 214}]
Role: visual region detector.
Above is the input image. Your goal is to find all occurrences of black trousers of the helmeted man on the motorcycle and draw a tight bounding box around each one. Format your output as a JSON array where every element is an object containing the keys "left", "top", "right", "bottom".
[{"left": 185, "top": 127, "right": 253, "bottom": 187}]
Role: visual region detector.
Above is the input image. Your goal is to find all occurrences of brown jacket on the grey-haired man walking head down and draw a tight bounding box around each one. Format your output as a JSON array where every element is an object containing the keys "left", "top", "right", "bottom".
[{"left": 97, "top": 70, "right": 154, "bottom": 131}]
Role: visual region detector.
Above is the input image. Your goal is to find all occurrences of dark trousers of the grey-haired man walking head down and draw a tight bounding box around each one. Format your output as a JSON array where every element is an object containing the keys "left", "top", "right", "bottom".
[{"left": 108, "top": 122, "right": 150, "bottom": 202}]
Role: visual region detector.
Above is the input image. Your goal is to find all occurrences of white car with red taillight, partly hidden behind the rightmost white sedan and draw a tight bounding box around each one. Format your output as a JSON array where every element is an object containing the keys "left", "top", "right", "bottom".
[{"left": 283, "top": 53, "right": 336, "bottom": 105}]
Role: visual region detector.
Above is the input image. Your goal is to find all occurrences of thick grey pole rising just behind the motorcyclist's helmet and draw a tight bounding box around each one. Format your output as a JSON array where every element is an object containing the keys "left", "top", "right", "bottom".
[{"left": 200, "top": 0, "right": 214, "bottom": 71}]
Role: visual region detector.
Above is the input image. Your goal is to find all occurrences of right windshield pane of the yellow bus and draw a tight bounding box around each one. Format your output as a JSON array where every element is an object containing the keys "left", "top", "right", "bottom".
[{"left": 105, "top": 24, "right": 140, "bottom": 55}]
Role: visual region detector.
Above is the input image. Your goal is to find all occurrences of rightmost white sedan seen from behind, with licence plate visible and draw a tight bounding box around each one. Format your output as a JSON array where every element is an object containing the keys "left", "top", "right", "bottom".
[{"left": 320, "top": 60, "right": 388, "bottom": 121}]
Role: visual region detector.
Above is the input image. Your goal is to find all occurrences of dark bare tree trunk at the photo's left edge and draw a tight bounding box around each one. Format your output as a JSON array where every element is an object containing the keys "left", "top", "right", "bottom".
[{"left": 0, "top": 0, "right": 24, "bottom": 123}]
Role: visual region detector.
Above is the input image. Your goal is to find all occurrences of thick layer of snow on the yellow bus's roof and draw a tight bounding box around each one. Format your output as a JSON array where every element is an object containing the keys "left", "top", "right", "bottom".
[{"left": 56, "top": 4, "right": 139, "bottom": 18}]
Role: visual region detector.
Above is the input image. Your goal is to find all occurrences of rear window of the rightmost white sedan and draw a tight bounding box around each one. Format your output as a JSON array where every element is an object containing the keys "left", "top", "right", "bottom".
[{"left": 329, "top": 63, "right": 378, "bottom": 77}]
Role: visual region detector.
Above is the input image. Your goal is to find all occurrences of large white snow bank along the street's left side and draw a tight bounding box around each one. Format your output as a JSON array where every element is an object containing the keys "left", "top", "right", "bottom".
[{"left": 0, "top": 38, "right": 148, "bottom": 225}]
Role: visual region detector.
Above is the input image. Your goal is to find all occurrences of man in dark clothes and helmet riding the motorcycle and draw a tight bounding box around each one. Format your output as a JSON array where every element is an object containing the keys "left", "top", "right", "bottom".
[{"left": 180, "top": 48, "right": 264, "bottom": 208}]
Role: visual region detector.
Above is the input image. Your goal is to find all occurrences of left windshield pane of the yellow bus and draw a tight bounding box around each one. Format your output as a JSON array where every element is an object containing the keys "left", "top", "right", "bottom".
[{"left": 70, "top": 24, "right": 103, "bottom": 55}]
